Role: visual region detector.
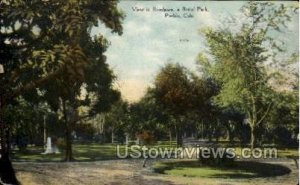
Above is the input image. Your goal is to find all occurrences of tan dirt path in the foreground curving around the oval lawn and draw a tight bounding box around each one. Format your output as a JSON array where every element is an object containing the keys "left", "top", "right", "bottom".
[{"left": 14, "top": 160, "right": 298, "bottom": 185}]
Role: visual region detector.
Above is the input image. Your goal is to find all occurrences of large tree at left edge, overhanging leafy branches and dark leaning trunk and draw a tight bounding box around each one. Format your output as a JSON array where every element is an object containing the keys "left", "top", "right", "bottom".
[{"left": 0, "top": 0, "right": 123, "bottom": 184}]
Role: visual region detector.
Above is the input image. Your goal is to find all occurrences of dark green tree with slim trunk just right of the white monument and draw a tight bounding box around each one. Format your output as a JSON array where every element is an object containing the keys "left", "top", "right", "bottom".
[{"left": 41, "top": 35, "right": 120, "bottom": 161}]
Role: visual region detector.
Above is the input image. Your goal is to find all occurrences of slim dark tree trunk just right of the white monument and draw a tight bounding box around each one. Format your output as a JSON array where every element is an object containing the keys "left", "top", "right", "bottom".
[{"left": 63, "top": 100, "right": 74, "bottom": 162}]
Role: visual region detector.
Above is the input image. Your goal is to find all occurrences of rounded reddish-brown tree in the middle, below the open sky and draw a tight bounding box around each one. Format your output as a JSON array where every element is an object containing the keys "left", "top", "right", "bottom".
[{"left": 151, "top": 64, "right": 217, "bottom": 145}]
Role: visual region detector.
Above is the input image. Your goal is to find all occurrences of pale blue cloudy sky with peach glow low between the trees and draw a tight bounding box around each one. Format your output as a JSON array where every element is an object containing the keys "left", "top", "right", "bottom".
[{"left": 92, "top": 1, "right": 299, "bottom": 102}]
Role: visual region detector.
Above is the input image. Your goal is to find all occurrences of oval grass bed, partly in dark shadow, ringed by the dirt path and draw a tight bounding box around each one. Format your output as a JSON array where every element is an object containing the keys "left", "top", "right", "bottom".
[{"left": 153, "top": 161, "right": 291, "bottom": 178}]
